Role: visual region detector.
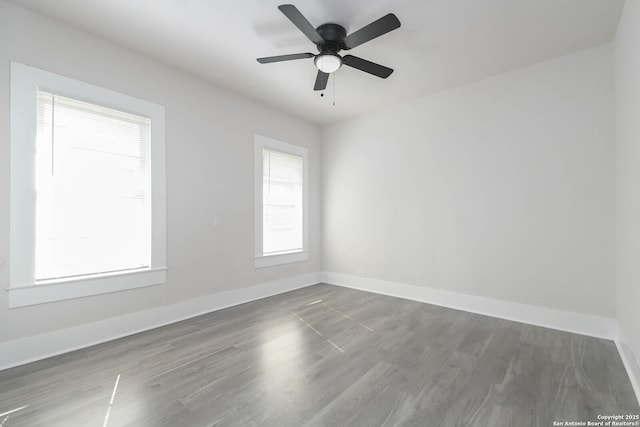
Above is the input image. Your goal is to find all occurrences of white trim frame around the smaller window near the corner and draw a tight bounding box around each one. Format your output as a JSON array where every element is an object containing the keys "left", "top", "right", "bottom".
[{"left": 254, "top": 135, "right": 309, "bottom": 268}]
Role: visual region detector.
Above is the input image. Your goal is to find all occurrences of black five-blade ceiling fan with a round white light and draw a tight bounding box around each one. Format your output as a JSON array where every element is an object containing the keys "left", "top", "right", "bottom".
[{"left": 257, "top": 4, "right": 400, "bottom": 90}]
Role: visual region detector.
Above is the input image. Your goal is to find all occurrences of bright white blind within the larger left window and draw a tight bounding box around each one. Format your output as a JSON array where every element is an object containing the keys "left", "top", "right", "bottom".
[{"left": 35, "top": 90, "right": 151, "bottom": 280}]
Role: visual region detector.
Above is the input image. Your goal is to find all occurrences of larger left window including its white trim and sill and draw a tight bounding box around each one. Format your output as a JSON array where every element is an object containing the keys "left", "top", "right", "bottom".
[{"left": 9, "top": 64, "right": 166, "bottom": 307}]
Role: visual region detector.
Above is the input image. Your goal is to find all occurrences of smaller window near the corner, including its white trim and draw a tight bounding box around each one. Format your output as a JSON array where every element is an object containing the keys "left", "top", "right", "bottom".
[{"left": 256, "top": 135, "right": 308, "bottom": 267}]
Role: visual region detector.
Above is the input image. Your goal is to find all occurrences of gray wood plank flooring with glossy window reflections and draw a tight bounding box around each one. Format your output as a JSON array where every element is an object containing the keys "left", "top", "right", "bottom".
[{"left": 0, "top": 284, "right": 640, "bottom": 427}]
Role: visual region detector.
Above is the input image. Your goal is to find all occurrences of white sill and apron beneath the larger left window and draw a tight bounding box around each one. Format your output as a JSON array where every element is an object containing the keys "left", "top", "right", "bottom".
[{"left": 7, "top": 268, "right": 167, "bottom": 308}]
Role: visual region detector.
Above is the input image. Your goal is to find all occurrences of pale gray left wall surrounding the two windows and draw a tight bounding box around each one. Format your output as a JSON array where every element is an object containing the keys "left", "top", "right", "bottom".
[{"left": 0, "top": 1, "right": 320, "bottom": 342}]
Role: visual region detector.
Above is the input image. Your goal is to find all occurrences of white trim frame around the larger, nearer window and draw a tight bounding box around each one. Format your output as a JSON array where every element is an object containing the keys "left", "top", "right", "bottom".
[{"left": 7, "top": 62, "right": 167, "bottom": 308}]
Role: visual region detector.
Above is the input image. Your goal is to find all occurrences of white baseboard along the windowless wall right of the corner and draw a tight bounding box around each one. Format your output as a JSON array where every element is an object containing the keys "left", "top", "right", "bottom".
[{"left": 321, "top": 272, "right": 617, "bottom": 340}]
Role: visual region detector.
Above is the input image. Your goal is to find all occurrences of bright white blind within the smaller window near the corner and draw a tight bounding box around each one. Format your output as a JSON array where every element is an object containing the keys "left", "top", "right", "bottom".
[{"left": 262, "top": 148, "right": 303, "bottom": 255}]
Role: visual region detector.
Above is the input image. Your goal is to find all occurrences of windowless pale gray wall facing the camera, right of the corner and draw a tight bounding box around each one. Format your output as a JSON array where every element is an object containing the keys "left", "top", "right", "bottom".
[{"left": 322, "top": 45, "right": 615, "bottom": 318}]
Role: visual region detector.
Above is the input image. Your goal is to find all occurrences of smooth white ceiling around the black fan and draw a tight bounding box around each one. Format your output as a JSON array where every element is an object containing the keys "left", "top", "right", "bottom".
[{"left": 12, "top": 0, "right": 624, "bottom": 124}]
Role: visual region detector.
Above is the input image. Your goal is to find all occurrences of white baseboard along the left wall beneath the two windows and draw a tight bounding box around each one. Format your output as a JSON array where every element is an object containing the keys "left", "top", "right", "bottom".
[{"left": 0, "top": 273, "right": 320, "bottom": 370}]
